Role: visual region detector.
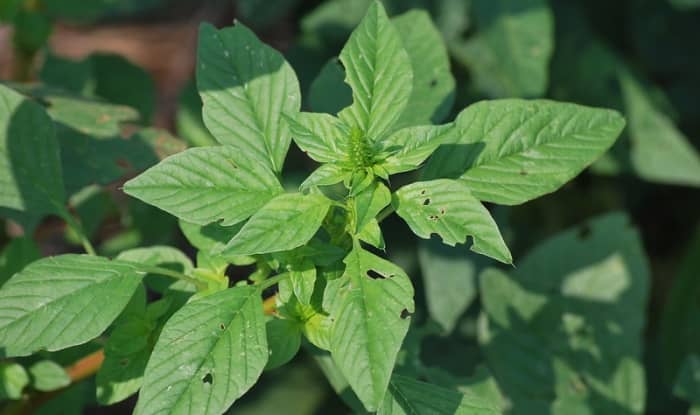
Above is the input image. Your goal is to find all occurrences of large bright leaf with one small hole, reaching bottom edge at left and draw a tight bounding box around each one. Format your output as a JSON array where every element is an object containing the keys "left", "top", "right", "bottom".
[{"left": 134, "top": 286, "right": 268, "bottom": 415}]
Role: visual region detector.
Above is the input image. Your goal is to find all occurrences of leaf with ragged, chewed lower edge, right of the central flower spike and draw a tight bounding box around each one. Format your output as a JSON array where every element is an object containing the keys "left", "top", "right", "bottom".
[{"left": 393, "top": 179, "right": 513, "bottom": 264}]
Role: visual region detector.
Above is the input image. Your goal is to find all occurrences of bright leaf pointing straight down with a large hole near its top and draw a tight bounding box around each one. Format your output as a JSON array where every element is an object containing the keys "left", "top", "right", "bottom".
[{"left": 331, "top": 242, "right": 413, "bottom": 411}]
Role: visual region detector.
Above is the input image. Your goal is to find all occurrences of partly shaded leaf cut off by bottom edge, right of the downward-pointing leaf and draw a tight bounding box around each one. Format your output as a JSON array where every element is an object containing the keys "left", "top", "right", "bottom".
[{"left": 377, "top": 375, "right": 501, "bottom": 415}]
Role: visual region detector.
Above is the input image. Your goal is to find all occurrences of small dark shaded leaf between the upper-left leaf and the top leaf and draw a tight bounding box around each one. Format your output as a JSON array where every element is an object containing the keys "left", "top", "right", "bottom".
[{"left": 309, "top": 58, "right": 352, "bottom": 115}]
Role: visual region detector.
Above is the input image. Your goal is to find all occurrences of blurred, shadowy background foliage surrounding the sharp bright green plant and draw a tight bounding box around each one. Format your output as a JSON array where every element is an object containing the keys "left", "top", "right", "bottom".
[{"left": 0, "top": 0, "right": 700, "bottom": 415}]
